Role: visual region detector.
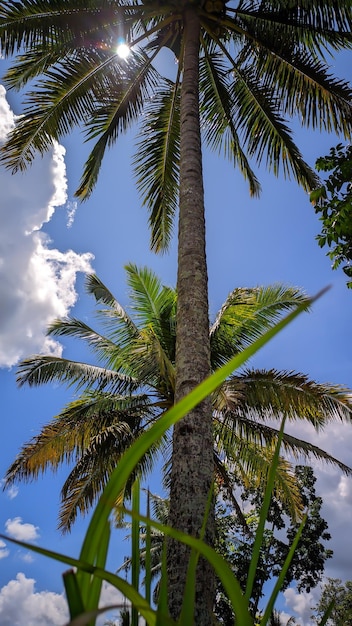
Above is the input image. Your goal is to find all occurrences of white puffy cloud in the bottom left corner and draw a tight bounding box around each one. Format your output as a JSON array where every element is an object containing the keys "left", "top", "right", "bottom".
[{"left": 0, "top": 573, "right": 68, "bottom": 626}]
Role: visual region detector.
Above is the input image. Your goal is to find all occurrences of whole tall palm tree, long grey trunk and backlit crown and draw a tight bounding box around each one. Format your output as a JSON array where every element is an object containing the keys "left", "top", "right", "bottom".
[{"left": 0, "top": 0, "right": 352, "bottom": 626}]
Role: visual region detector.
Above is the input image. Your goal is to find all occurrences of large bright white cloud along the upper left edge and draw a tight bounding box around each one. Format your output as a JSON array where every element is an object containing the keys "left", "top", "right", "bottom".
[{"left": 0, "top": 85, "right": 93, "bottom": 367}]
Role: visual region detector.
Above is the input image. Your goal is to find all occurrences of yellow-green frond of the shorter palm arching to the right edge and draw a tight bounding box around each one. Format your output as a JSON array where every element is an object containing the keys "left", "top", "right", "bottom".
[{"left": 213, "top": 370, "right": 352, "bottom": 474}]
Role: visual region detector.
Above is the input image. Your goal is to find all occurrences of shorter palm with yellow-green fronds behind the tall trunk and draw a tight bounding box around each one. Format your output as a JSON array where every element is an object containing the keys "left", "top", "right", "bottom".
[{"left": 6, "top": 264, "right": 352, "bottom": 531}]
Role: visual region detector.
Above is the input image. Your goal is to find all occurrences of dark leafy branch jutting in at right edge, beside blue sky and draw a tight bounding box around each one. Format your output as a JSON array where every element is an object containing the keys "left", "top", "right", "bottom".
[{"left": 310, "top": 144, "right": 352, "bottom": 288}]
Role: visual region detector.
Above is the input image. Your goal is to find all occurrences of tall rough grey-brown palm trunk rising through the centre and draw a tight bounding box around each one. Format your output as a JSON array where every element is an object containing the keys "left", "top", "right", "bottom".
[{"left": 168, "top": 6, "right": 214, "bottom": 626}]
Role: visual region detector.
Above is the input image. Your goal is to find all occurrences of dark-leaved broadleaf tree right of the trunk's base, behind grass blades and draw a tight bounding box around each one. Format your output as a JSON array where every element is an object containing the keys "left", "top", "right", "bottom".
[{"left": 216, "top": 466, "right": 332, "bottom": 626}]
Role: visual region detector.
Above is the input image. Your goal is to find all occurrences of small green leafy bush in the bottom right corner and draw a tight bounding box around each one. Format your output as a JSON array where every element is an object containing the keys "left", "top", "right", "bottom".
[{"left": 314, "top": 578, "right": 352, "bottom": 626}]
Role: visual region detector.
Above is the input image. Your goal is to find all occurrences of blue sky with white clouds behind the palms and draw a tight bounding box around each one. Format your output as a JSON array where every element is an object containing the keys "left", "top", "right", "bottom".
[{"left": 0, "top": 45, "right": 352, "bottom": 626}]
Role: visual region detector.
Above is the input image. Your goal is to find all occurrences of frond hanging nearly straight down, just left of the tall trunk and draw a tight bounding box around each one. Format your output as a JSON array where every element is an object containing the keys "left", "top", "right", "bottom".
[{"left": 134, "top": 80, "right": 180, "bottom": 251}]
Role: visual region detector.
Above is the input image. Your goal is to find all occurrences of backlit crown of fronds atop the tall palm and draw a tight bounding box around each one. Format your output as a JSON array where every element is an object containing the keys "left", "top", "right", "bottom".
[{"left": 0, "top": 0, "right": 352, "bottom": 249}]
